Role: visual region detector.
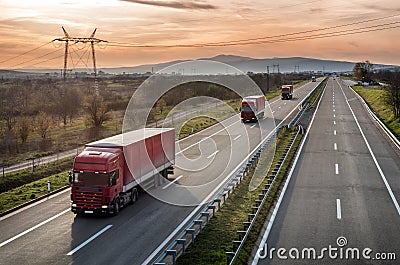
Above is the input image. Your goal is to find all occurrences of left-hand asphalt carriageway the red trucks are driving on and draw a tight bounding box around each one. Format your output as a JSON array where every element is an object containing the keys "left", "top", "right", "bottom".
[{"left": 0, "top": 79, "right": 319, "bottom": 264}]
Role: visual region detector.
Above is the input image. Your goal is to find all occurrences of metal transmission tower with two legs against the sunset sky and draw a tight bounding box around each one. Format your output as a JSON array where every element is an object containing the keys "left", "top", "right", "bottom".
[{"left": 53, "top": 27, "right": 107, "bottom": 93}]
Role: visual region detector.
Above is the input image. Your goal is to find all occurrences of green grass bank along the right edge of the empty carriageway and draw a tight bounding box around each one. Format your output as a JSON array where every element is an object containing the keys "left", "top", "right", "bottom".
[{"left": 353, "top": 86, "right": 400, "bottom": 137}]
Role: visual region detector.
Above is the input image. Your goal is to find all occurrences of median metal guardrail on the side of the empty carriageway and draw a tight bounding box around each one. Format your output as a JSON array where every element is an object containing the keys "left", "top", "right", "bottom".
[{"left": 226, "top": 126, "right": 302, "bottom": 265}]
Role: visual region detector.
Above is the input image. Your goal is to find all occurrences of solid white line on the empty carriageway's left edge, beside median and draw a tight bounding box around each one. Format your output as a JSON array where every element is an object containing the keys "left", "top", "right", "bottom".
[{"left": 251, "top": 82, "right": 325, "bottom": 265}]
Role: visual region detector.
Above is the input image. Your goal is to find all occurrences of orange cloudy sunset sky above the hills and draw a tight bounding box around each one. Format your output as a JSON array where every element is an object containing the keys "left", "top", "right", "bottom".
[{"left": 0, "top": 0, "right": 400, "bottom": 69}]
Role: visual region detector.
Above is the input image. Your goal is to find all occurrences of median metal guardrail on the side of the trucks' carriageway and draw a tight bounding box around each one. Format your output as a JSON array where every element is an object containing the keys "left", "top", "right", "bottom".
[{"left": 153, "top": 127, "right": 282, "bottom": 265}]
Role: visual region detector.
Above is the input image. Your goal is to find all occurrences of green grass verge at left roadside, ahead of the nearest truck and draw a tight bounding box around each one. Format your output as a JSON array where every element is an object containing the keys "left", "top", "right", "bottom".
[{"left": 0, "top": 171, "right": 68, "bottom": 212}]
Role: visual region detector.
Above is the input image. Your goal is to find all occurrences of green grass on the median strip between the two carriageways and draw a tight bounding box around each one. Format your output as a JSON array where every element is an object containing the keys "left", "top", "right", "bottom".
[{"left": 177, "top": 129, "right": 300, "bottom": 265}]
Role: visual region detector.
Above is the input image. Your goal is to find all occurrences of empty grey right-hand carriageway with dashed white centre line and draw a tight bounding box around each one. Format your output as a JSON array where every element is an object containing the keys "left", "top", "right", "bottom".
[{"left": 253, "top": 78, "right": 400, "bottom": 265}]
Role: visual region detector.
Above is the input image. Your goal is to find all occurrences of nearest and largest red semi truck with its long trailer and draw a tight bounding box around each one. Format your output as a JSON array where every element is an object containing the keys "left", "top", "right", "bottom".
[{"left": 70, "top": 128, "right": 175, "bottom": 215}]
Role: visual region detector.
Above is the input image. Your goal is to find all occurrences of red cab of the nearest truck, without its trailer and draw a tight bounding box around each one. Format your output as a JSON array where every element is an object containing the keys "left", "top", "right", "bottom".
[{"left": 71, "top": 147, "right": 137, "bottom": 214}]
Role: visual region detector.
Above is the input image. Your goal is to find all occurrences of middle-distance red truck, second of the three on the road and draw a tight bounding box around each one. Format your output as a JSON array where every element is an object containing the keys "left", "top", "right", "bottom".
[{"left": 240, "top": 95, "right": 265, "bottom": 122}]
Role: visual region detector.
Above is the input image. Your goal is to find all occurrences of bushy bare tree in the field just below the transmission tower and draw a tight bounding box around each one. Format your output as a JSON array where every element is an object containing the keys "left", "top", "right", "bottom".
[{"left": 84, "top": 94, "right": 109, "bottom": 127}]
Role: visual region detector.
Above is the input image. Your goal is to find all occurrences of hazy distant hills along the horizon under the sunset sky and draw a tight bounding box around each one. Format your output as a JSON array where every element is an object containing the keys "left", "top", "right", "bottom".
[{"left": 101, "top": 55, "right": 395, "bottom": 74}]
